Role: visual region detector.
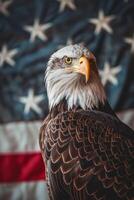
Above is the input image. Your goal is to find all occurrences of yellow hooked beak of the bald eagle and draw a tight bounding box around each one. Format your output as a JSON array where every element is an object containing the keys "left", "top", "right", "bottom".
[{"left": 72, "top": 56, "right": 90, "bottom": 83}]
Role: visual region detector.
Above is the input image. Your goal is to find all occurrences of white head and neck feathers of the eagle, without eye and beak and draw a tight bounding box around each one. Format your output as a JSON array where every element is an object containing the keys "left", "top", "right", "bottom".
[{"left": 46, "top": 45, "right": 106, "bottom": 110}]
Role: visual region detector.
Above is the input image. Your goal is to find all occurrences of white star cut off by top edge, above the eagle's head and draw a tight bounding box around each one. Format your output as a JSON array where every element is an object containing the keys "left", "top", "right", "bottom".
[{"left": 57, "top": 0, "right": 76, "bottom": 12}]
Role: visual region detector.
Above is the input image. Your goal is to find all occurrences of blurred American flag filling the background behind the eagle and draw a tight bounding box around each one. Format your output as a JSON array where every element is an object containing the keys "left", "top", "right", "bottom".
[{"left": 0, "top": 0, "right": 134, "bottom": 200}]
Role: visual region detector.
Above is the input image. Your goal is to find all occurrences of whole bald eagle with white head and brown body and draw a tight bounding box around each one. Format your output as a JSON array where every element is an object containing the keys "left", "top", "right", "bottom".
[{"left": 39, "top": 45, "right": 134, "bottom": 200}]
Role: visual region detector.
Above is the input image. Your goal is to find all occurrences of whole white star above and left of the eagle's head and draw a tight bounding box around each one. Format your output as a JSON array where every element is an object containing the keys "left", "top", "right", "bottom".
[{"left": 24, "top": 19, "right": 52, "bottom": 42}]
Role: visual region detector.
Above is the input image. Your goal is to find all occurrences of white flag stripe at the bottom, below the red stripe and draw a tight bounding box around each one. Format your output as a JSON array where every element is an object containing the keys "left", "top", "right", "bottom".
[{"left": 0, "top": 181, "right": 48, "bottom": 200}]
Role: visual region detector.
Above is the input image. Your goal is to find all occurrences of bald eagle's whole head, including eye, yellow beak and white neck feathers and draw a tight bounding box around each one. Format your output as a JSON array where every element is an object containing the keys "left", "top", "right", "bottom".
[{"left": 45, "top": 44, "right": 106, "bottom": 110}]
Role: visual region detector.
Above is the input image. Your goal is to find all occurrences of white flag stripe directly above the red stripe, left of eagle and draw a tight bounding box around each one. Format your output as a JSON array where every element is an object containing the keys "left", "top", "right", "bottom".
[{"left": 0, "top": 121, "right": 41, "bottom": 153}]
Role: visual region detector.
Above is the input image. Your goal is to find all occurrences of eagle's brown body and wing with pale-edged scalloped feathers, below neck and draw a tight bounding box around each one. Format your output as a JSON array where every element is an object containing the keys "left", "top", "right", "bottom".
[{"left": 40, "top": 111, "right": 134, "bottom": 200}]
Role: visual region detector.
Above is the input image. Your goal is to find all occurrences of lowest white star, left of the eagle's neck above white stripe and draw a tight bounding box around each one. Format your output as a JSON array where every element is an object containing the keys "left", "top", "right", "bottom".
[{"left": 19, "top": 89, "right": 44, "bottom": 114}]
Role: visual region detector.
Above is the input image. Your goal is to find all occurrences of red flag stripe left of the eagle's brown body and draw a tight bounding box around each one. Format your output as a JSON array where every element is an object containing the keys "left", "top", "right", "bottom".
[{"left": 0, "top": 153, "right": 45, "bottom": 183}]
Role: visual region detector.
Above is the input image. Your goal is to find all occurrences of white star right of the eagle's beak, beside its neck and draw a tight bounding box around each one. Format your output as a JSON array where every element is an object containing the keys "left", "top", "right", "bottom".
[{"left": 99, "top": 62, "right": 121, "bottom": 85}]
